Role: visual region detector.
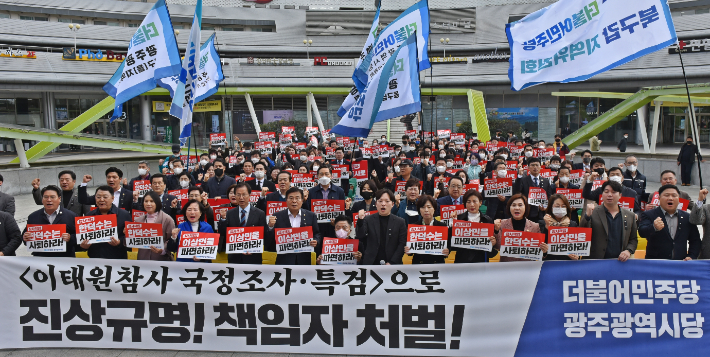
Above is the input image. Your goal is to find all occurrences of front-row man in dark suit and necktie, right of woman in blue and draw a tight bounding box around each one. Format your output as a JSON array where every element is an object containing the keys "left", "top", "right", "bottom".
[{"left": 219, "top": 182, "right": 266, "bottom": 264}]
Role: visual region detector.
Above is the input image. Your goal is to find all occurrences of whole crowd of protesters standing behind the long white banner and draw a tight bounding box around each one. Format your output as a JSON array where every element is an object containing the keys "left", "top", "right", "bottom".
[{"left": 0, "top": 132, "right": 710, "bottom": 265}]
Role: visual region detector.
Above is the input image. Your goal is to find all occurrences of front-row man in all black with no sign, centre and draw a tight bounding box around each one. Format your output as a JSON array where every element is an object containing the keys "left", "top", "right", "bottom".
[{"left": 356, "top": 189, "right": 407, "bottom": 265}]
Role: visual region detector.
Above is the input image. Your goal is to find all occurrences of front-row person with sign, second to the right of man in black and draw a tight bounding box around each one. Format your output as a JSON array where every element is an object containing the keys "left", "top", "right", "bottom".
[{"left": 456, "top": 190, "right": 498, "bottom": 264}]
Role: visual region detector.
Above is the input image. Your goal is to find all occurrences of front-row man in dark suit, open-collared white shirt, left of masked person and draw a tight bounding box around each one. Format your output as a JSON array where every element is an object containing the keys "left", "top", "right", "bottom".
[{"left": 264, "top": 187, "right": 323, "bottom": 265}]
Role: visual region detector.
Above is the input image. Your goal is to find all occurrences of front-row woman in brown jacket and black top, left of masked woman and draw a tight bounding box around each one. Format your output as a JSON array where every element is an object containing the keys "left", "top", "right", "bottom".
[{"left": 493, "top": 193, "right": 549, "bottom": 262}]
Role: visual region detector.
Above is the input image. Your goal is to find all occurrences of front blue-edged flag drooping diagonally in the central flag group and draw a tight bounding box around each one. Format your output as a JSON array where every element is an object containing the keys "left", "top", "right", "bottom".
[{"left": 330, "top": 35, "right": 418, "bottom": 138}]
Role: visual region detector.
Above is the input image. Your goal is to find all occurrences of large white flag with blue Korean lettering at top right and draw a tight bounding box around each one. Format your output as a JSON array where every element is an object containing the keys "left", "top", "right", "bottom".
[{"left": 506, "top": 0, "right": 677, "bottom": 90}]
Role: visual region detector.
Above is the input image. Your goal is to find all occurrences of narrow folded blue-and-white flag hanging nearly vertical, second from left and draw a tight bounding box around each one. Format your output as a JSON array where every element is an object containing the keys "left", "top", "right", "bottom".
[{"left": 170, "top": 0, "right": 202, "bottom": 145}]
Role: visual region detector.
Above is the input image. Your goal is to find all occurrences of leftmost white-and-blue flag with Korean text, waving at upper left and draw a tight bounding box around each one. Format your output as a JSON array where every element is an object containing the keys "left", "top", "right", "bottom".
[{"left": 103, "top": 0, "right": 180, "bottom": 121}]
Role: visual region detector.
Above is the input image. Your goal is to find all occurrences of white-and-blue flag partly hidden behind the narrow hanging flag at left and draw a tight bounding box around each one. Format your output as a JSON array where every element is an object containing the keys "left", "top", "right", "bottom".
[{"left": 158, "top": 34, "right": 224, "bottom": 104}]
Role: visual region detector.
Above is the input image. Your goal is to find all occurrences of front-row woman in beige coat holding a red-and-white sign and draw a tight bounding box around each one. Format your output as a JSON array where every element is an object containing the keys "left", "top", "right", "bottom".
[{"left": 136, "top": 191, "right": 175, "bottom": 261}]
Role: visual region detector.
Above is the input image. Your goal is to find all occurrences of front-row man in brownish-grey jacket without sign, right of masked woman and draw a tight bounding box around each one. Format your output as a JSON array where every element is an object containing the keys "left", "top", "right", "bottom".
[{"left": 580, "top": 181, "right": 638, "bottom": 262}]
